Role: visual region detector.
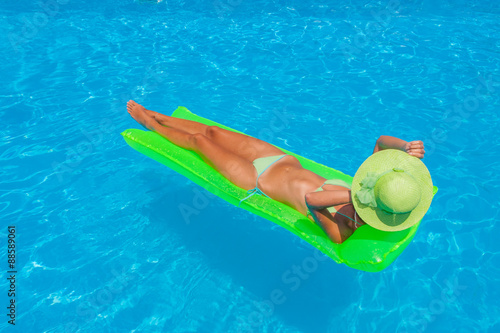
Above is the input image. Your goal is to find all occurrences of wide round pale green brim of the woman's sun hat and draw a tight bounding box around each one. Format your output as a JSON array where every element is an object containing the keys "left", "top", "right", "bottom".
[{"left": 351, "top": 149, "right": 433, "bottom": 231}]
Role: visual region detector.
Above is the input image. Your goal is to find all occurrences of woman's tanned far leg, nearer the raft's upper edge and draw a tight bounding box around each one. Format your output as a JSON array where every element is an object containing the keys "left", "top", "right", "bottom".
[{"left": 127, "top": 101, "right": 284, "bottom": 161}]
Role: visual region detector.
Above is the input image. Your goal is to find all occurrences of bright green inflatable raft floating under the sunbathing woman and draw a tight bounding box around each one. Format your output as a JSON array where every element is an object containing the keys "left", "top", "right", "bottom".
[{"left": 121, "top": 107, "right": 437, "bottom": 272}]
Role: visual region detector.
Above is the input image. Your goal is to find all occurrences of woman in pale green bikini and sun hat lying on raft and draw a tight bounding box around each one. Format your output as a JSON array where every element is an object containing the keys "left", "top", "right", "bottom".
[{"left": 127, "top": 101, "right": 432, "bottom": 243}]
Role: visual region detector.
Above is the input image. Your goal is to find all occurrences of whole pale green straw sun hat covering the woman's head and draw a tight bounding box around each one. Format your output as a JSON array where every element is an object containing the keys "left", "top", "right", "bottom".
[{"left": 351, "top": 149, "right": 433, "bottom": 231}]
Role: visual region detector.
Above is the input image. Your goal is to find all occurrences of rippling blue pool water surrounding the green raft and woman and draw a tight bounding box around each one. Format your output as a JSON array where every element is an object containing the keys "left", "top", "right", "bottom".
[{"left": 0, "top": 0, "right": 500, "bottom": 333}]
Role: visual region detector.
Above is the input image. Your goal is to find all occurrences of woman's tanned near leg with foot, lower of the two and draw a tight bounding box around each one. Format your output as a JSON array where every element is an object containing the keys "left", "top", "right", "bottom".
[{"left": 127, "top": 104, "right": 257, "bottom": 190}]
